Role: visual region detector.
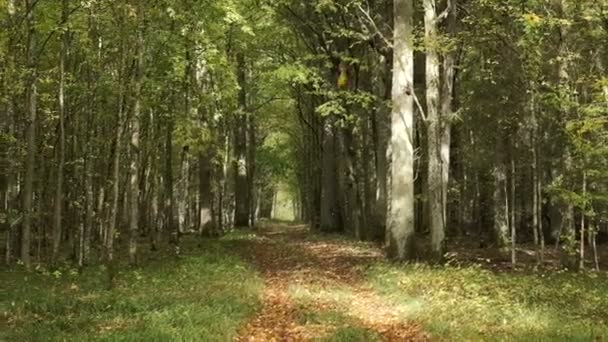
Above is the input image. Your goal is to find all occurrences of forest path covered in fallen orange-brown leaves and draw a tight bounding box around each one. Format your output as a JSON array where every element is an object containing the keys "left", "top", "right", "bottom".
[{"left": 236, "top": 223, "right": 428, "bottom": 342}]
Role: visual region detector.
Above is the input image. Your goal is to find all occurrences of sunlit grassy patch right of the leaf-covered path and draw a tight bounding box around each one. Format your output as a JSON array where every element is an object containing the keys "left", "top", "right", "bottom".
[{"left": 368, "top": 263, "right": 608, "bottom": 341}]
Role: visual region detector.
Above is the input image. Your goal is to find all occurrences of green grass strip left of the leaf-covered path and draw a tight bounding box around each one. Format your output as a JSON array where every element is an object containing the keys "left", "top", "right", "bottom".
[{"left": 0, "top": 235, "right": 262, "bottom": 341}]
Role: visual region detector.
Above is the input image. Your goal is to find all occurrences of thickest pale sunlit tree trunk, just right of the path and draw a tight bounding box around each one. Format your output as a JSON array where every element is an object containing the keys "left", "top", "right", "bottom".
[{"left": 386, "top": 0, "right": 415, "bottom": 260}]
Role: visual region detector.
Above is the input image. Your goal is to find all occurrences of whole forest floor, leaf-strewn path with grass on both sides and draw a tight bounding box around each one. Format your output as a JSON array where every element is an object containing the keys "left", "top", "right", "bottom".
[{"left": 0, "top": 222, "right": 608, "bottom": 342}]
